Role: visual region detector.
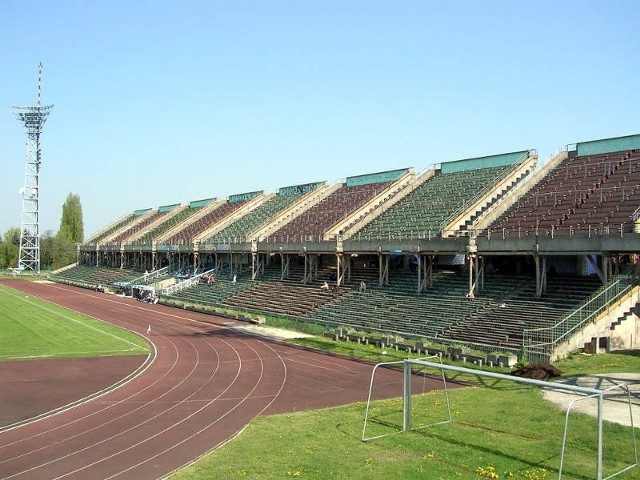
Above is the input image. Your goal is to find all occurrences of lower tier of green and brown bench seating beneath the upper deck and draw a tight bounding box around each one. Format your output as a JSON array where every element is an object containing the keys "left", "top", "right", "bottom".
[{"left": 53, "top": 265, "right": 599, "bottom": 350}]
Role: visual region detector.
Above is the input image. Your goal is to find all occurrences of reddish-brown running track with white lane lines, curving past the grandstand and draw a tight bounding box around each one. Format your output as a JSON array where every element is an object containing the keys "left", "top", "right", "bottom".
[{"left": 0, "top": 280, "right": 450, "bottom": 480}]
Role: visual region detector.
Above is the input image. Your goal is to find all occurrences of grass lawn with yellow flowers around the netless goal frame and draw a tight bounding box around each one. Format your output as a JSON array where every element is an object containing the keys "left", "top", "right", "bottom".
[{"left": 171, "top": 348, "right": 640, "bottom": 480}]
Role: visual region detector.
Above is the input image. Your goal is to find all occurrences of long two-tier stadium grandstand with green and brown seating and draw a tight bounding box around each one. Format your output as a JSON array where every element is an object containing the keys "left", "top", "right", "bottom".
[{"left": 52, "top": 135, "right": 640, "bottom": 360}]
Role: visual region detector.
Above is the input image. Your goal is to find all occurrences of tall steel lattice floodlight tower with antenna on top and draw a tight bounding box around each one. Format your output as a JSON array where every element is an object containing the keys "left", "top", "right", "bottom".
[{"left": 13, "top": 63, "right": 53, "bottom": 273}]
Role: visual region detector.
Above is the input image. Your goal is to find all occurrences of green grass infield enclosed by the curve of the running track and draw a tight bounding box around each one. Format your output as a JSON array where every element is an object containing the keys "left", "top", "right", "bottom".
[{"left": 0, "top": 285, "right": 149, "bottom": 360}]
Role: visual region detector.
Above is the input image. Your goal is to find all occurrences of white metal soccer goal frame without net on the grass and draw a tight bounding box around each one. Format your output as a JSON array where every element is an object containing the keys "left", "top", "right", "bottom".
[{"left": 361, "top": 357, "right": 638, "bottom": 480}]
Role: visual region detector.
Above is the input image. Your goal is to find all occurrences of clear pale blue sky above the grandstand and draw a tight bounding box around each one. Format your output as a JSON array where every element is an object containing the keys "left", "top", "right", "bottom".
[{"left": 0, "top": 0, "right": 640, "bottom": 237}]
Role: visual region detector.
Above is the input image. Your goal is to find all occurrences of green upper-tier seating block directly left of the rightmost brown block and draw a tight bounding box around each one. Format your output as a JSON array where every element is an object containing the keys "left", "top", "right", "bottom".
[{"left": 355, "top": 166, "right": 511, "bottom": 239}]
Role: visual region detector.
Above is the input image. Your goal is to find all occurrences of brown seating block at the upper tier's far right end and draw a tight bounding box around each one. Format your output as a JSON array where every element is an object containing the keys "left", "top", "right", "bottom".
[{"left": 491, "top": 150, "right": 640, "bottom": 236}]
